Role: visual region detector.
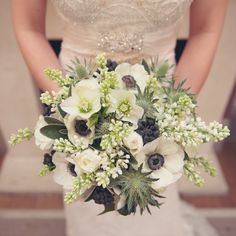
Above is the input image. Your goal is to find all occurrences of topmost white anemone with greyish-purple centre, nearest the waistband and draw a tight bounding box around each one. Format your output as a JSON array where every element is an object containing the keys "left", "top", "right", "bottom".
[{"left": 115, "top": 63, "right": 149, "bottom": 92}]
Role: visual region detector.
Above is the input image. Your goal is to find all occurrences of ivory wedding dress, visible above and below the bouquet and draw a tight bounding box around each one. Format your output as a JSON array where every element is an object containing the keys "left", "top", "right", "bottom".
[{"left": 52, "top": 0, "right": 218, "bottom": 236}]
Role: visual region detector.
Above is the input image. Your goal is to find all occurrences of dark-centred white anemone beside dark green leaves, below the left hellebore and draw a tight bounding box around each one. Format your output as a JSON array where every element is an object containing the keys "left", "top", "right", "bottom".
[{"left": 64, "top": 115, "right": 95, "bottom": 146}]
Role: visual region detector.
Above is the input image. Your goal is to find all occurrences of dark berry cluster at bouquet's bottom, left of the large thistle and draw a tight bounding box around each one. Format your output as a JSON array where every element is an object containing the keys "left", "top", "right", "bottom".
[{"left": 91, "top": 186, "right": 114, "bottom": 205}]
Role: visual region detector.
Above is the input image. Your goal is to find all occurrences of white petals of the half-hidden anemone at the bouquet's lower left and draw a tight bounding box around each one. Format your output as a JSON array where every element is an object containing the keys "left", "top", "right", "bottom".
[{"left": 53, "top": 152, "right": 73, "bottom": 190}]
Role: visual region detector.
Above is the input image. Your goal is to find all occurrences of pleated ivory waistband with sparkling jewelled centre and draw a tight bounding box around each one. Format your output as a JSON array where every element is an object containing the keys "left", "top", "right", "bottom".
[{"left": 58, "top": 27, "right": 176, "bottom": 66}]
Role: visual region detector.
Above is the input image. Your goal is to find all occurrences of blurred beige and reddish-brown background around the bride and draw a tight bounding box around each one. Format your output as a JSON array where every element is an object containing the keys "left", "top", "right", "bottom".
[{"left": 0, "top": 0, "right": 236, "bottom": 236}]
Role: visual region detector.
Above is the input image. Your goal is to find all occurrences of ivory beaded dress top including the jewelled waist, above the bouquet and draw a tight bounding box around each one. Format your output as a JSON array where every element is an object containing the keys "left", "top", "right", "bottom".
[{"left": 51, "top": 0, "right": 192, "bottom": 63}]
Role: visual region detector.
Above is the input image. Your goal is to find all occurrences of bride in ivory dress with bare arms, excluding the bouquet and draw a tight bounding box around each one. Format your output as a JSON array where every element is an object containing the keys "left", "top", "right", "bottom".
[{"left": 12, "top": 0, "right": 227, "bottom": 236}]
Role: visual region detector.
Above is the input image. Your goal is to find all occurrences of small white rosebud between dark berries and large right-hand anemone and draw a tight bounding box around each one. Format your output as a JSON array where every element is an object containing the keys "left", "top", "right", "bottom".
[{"left": 123, "top": 131, "right": 143, "bottom": 156}]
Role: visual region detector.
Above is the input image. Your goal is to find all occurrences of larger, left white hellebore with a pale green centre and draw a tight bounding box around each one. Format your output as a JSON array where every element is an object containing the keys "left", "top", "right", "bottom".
[{"left": 61, "top": 78, "right": 101, "bottom": 119}]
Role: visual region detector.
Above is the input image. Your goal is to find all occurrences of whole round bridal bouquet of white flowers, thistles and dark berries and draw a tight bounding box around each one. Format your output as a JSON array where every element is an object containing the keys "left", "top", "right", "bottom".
[{"left": 9, "top": 55, "right": 229, "bottom": 215}]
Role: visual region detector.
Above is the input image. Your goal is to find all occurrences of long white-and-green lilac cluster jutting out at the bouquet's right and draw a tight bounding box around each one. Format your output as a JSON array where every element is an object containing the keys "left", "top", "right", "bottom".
[{"left": 158, "top": 95, "right": 229, "bottom": 146}]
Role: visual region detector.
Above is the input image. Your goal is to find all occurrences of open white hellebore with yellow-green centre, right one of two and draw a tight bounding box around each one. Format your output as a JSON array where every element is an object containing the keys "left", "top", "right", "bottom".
[{"left": 108, "top": 90, "right": 144, "bottom": 125}]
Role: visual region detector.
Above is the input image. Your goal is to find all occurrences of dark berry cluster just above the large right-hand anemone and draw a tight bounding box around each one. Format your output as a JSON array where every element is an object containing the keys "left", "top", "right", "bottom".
[{"left": 136, "top": 118, "right": 160, "bottom": 144}]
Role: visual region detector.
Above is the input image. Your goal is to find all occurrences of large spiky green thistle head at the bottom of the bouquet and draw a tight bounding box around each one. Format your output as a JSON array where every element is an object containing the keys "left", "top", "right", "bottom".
[{"left": 112, "top": 165, "right": 162, "bottom": 215}]
